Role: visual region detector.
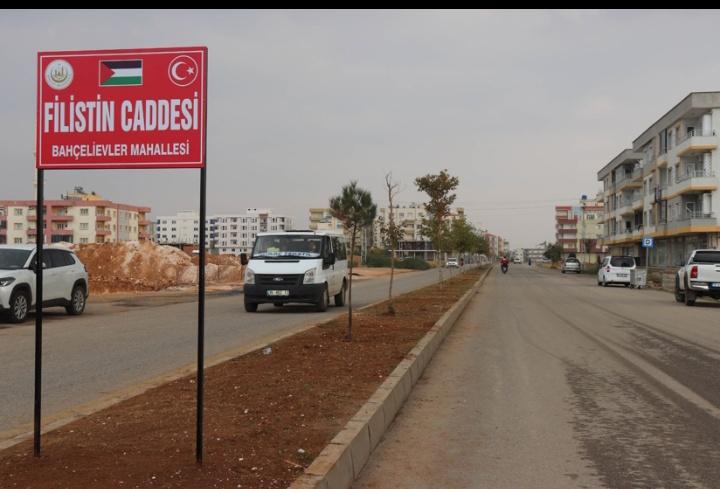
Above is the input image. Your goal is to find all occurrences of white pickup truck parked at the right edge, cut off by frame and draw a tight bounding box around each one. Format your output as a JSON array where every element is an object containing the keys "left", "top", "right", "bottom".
[{"left": 675, "top": 250, "right": 720, "bottom": 306}]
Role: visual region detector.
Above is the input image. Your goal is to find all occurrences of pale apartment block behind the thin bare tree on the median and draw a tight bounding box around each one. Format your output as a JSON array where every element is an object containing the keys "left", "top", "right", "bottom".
[{"left": 372, "top": 202, "right": 465, "bottom": 260}]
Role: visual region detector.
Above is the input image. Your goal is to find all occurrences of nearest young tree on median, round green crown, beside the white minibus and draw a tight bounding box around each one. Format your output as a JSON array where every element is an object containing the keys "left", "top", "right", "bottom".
[{"left": 330, "top": 180, "right": 377, "bottom": 341}]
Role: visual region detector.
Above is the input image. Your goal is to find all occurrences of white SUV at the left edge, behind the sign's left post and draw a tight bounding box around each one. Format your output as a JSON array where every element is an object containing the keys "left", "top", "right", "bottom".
[{"left": 0, "top": 245, "right": 88, "bottom": 323}]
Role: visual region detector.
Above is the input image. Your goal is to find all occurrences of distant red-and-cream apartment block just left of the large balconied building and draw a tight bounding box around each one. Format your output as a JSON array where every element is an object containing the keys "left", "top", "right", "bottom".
[{"left": 555, "top": 195, "right": 604, "bottom": 264}]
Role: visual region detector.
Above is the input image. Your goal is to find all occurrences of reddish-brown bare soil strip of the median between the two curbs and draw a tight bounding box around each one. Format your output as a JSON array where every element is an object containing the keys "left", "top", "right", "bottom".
[{"left": 0, "top": 270, "right": 480, "bottom": 489}]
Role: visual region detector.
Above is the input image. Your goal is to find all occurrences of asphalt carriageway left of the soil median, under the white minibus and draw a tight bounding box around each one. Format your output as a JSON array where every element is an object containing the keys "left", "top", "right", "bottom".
[{"left": 0, "top": 270, "right": 456, "bottom": 434}]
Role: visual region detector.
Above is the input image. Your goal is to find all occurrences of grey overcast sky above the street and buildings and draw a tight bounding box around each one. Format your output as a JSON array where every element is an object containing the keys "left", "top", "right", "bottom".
[{"left": 0, "top": 11, "right": 720, "bottom": 247}]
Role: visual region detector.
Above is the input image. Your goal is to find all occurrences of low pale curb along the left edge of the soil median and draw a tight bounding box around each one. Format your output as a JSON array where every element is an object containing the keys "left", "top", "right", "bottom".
[{"left": 0, "top": 266, "right": 466, "bottom": 450}]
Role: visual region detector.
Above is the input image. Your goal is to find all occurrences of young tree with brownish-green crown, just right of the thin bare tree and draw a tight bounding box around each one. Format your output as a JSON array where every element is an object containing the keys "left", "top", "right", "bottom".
[{"left": 415, "top": 170, "right": 460, "bottom": 282}]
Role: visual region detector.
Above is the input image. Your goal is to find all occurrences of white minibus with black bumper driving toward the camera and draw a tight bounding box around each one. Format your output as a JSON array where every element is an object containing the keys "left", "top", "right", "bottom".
[{"left": 243, "top": 231, "right": 348, "bottom": 312}]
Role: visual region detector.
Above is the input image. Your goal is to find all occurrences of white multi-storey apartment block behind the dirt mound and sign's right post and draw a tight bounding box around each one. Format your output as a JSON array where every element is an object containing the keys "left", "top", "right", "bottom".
[{"left": 155, "top": 209, "right": 292, "bottom": 255}]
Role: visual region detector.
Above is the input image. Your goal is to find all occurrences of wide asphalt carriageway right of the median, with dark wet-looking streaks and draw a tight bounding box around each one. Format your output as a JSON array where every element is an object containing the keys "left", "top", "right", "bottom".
[{"left": 354, "top": 265, "right": 720, "bottom": 489}]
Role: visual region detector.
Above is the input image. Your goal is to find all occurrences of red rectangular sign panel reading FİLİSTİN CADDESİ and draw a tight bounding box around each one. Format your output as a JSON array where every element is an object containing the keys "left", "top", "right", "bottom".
[{"left": 36, "top": 47, "right": 207, "bottom": 170}]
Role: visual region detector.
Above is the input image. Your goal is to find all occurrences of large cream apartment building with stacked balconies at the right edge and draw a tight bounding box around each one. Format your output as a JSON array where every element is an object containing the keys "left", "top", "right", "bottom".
[{"left": 597, "top": 92, "right": 720, "bottom": 267}]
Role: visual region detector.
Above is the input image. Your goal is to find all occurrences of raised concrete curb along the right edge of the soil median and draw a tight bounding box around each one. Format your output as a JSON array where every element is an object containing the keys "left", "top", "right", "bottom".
[{"left": 289, "top": 268, "right": 492, "bottom": 489}]
